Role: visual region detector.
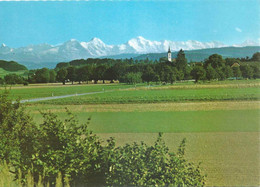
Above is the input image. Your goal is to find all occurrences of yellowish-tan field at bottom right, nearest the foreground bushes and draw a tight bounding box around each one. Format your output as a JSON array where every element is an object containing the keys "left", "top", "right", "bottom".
[{"left": 98, "top": 132, "right": 260, "bottom": 186}]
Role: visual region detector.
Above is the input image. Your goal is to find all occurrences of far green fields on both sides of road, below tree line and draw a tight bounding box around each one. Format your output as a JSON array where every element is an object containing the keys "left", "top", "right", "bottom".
[{"left": 0, "top": 80, "right": 260, "bottom": 101}]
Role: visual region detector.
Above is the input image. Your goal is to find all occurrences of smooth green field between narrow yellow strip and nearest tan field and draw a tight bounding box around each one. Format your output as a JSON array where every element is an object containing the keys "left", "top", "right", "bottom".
[{"left": 29, "top": 110, "right": 260, "bottom": 133}]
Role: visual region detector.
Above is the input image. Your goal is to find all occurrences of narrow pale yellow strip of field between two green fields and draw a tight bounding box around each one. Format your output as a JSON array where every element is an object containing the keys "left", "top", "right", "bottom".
[{"left": 27, "top": 101, "right": 260, "bottom": 113}]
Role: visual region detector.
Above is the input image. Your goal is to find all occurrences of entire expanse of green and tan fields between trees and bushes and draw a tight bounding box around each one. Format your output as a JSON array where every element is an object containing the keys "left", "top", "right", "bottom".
[{"left": 3, "top": 80, "right": 260, "bottom": 186}]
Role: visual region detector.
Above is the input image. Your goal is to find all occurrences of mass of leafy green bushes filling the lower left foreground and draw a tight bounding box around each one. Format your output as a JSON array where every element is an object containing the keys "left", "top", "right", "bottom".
[{"left": 0, "top": 90, "right": 205, "bottom": 186}]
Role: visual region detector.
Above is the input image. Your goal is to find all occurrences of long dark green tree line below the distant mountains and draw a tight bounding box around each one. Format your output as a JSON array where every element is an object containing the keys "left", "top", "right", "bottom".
[{"left": 0, "top": 50, "right": 260, "bottom": 84}]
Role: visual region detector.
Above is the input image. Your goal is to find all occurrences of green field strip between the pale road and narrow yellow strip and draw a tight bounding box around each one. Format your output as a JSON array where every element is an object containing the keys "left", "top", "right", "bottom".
[{"left": 38, "top": 87, "right": 260, "bottom": 105}]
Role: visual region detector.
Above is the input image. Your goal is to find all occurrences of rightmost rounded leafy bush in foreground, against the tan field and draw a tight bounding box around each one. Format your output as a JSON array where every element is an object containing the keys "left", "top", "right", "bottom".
[{"left": 106, "top": 133, "right": 205, "bottom": 186}]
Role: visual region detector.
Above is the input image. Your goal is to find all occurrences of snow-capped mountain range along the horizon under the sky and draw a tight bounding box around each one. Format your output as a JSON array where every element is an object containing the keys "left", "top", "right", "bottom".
[{"left": 0, "top": 36, "right": 260, "bottom": 63}]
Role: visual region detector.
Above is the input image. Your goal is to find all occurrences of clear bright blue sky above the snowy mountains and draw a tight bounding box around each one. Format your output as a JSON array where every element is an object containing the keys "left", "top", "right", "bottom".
[{"left": 0, "top": 0, "right": 260, "bottom": 47}]
